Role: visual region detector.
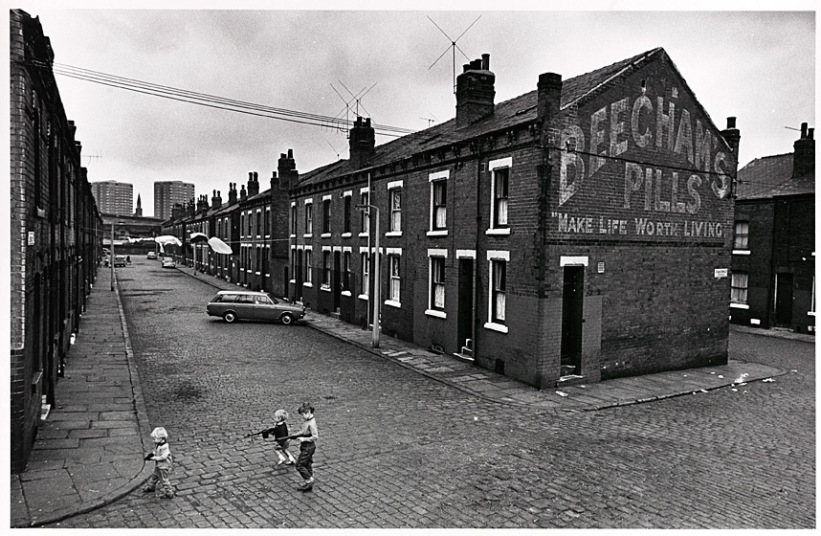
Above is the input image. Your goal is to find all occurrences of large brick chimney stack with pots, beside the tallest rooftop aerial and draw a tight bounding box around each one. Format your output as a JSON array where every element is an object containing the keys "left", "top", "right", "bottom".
[{"left": 456, "top": 54, "right": 496, "bottom": 128}]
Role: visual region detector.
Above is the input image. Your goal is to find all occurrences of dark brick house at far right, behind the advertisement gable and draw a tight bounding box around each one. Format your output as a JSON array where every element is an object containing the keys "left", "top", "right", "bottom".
[{"left": 730, "top": 123, "right": 815, "bottom": 333}]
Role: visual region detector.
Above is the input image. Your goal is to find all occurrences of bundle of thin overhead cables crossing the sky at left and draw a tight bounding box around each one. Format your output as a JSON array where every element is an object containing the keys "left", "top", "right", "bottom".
[{"left": 29, "top": 62, "right": 416, "bottom": 137}]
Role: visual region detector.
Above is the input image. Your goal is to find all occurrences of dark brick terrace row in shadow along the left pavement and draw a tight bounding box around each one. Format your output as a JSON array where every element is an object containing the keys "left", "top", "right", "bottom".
[{"left": 7, "top": 9, "right": 102, "bottom": 473}]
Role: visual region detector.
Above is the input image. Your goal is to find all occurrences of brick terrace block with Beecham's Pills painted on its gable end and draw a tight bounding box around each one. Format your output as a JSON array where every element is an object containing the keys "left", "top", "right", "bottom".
[{"left": 289, "top": 48, "right": 740, "bottom": 388}]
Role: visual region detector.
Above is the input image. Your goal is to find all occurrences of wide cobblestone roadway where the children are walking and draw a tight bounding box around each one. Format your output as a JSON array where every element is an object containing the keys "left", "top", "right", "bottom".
[{"left": 50, "top": 259, "right": 816, "bottom": 529}]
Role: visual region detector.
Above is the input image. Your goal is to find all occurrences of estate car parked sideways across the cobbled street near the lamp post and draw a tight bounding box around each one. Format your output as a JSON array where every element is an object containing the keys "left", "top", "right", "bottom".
[{"left": 206, "top": 290, "right": 305, "bottom": 326}]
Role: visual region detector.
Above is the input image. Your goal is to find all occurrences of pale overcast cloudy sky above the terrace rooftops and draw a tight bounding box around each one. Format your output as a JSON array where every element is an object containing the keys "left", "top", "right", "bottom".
[{"left": 11, "top": 0, "right": 816, "bottom": 216}]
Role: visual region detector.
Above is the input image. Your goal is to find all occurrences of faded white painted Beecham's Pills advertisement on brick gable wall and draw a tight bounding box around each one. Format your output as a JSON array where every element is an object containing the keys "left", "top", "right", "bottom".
[{"left": 550, "top": 71, "right": 736, "bottom": 242}]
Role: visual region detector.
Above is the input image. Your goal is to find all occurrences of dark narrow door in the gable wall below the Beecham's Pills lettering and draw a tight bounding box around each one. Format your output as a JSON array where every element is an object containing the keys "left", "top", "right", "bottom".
[{"left": 561, "top": 266, "right": 584, "bottom": 376}]
